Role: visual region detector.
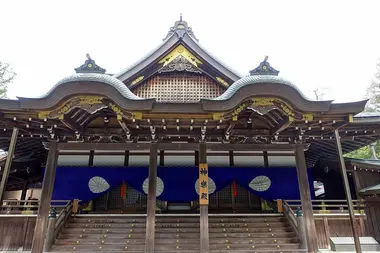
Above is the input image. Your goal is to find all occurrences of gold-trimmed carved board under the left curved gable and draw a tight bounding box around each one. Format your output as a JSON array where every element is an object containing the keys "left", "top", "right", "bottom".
[{"left": 38, "top": 96, "right": 142, "bottom": 120}]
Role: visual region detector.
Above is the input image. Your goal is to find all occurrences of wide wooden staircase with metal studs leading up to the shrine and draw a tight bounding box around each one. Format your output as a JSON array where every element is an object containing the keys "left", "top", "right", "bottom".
[{"left": 52, "top": 215, "right": 306, "bottom": 253}]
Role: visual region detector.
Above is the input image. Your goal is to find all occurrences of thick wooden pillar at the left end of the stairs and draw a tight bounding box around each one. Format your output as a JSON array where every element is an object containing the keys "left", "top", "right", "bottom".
[{"left": 32, "top": 141, "right": 59, "bottom": 253}]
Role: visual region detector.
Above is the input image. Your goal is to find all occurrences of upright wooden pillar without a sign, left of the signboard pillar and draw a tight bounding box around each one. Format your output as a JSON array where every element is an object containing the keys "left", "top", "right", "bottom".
[{"left": 145, "top": 142, "right": 158, "bottom": 253}]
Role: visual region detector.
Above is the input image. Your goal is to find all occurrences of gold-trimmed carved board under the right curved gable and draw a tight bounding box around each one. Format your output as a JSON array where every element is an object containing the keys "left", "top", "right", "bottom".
[{"left": 213, "top": 97, "right": 313, "bottom": 121}]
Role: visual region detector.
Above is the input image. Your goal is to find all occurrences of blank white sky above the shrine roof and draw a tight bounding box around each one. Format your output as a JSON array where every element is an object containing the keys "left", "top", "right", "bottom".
[{"left": 0, "top": 0, "right": 380, "bottom": 102}]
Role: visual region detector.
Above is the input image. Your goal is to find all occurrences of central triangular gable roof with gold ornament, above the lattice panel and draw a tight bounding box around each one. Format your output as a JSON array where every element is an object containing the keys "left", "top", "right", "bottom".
[{"left": 114, "top": 20, "right": 241, "bottom": 91}]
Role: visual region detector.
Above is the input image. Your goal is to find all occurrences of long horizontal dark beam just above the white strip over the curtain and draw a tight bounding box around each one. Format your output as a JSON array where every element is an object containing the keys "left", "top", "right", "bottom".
[{"left": 44, "top": 142, "right": 309, "bottom": 152}]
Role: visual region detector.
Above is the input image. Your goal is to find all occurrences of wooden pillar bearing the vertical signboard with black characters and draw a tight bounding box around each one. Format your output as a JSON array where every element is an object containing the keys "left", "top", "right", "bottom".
[{"left": 199, "top": 142, "right": 209, "bottom": 253}]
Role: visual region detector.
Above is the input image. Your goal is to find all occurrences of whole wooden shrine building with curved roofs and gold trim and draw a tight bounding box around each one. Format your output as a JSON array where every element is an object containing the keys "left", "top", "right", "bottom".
[{"left": 0, "top": 17, "right": 380, "bottom": 253}]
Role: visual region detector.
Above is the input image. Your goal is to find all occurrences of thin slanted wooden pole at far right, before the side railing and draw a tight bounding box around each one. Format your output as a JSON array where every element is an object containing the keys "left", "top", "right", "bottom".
[{"left": 334, "top": 129, "right": 362, "bottom": 253}]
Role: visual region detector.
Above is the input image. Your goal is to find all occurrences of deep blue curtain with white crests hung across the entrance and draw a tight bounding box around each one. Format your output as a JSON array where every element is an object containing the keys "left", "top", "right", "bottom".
[{"left": 48, "top": 167, "right": 314, "bottom": 202}]
